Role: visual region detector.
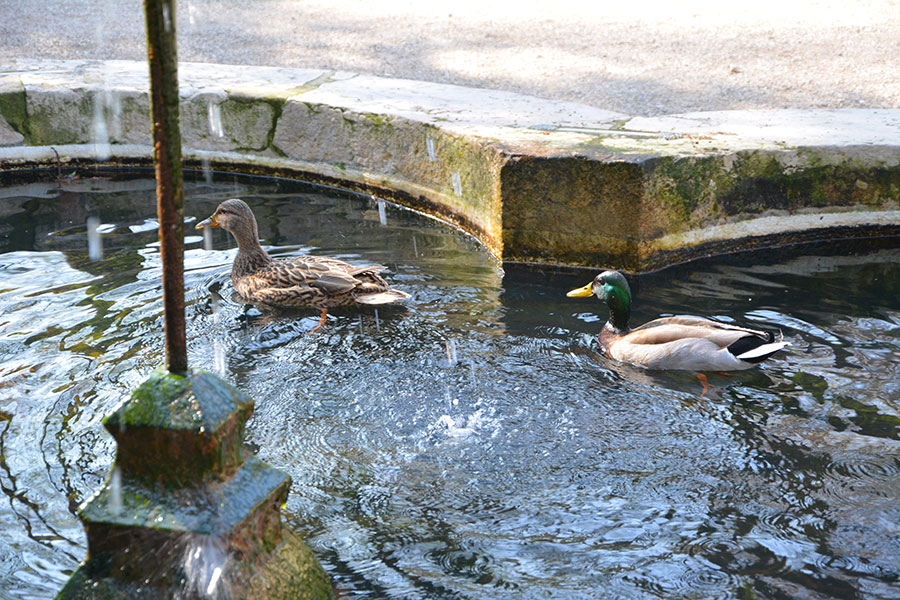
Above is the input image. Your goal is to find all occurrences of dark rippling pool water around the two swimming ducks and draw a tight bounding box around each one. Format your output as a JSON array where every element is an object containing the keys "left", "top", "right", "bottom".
[{"left": 0, "top": 174, "right": 900, "bottom": 599}]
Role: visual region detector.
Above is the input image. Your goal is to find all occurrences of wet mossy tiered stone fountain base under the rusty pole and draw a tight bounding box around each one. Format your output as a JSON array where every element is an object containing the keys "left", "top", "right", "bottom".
[{"left": 58, "top": 372, "right": 333, "bottom": 600}]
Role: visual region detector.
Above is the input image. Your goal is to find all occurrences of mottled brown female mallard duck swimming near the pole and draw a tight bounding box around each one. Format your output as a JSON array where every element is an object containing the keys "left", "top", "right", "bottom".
[{"left": 196, "top": 198, "right": 409, "bottom": 329}]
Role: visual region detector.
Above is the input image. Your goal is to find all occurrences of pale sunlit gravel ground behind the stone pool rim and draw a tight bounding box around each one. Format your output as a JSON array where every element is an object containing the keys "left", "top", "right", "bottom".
[{"left": 0, "top": 0, "right": 900, "bottom": 116}]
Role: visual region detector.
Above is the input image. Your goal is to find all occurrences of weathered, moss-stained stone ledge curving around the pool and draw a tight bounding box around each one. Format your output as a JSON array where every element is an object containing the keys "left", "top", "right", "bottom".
[{"left": 0, "top": 61, "right": 900, "bottom": 271}]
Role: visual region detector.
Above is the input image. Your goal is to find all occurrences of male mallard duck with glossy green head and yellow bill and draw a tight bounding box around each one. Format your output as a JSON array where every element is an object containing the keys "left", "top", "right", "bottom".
[{"left": 567, "top": 271, "right": 790, "bottom": 371}]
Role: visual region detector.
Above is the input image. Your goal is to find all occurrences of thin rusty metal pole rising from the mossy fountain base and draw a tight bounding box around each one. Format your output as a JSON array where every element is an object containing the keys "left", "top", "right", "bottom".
[{"left": 144, "top": 0, "right": 188, "bottom": 373}]
